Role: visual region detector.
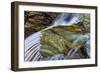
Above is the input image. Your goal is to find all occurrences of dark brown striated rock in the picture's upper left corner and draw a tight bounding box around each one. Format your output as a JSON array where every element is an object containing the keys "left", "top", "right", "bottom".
[{"left": 24, "top": 11, "right": 59, "bottom": 38}]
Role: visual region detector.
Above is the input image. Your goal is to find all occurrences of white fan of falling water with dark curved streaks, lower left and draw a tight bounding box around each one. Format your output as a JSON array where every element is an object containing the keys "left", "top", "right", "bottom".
[{"left": 24, "top": 32, "right": 41, "bottom": 61}]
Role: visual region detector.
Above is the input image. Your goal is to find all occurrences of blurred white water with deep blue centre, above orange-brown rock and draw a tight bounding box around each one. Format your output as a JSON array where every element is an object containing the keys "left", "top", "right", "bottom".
[{"left": 52, "top": 13, "right": 80, "bottom": 26}]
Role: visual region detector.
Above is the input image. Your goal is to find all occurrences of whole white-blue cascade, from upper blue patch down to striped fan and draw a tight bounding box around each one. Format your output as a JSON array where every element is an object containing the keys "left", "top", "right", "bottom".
[{"left": 24, "top": 13, "right": 80, "bottom": 62}]
